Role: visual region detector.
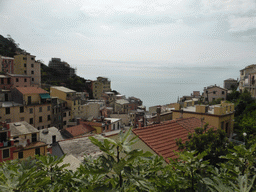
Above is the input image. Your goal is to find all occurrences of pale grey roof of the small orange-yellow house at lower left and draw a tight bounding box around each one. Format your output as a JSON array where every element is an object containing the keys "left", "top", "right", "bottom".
[{"left": 9, "top": 121, "right": 39, "bottom": 137}]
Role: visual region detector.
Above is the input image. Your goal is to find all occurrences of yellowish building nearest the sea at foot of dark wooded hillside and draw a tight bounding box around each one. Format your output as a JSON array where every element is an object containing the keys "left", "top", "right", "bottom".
[{"left": 92, "top": 77, "right": 111, "bottom": 99}]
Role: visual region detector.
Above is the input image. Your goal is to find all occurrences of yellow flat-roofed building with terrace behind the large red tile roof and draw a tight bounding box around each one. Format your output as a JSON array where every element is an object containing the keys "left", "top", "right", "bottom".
[{"left": 172, "top": 102, "right": 234, "bottom": 136}]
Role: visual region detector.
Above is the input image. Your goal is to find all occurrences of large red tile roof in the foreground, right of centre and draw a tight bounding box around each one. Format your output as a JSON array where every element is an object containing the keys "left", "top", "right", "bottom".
[{"left": 132, "top": 117, "right": 214, "bottom": 163}]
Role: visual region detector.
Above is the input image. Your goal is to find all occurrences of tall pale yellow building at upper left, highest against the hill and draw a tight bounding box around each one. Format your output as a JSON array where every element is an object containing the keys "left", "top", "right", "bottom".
[{"left": 14, "top": 53, "right": 41, "bottom": 87}]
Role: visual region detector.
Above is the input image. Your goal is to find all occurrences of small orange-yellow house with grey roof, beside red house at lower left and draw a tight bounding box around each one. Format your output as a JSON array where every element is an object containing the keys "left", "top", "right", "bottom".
[{"left": 9, "top": 121, "right": 47, "bottom": 160}]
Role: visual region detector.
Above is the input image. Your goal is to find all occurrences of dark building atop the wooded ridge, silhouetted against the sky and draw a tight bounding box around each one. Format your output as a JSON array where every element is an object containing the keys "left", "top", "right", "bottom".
[{"left": 48, "top": 58, "right": 76, "bottom": 79}]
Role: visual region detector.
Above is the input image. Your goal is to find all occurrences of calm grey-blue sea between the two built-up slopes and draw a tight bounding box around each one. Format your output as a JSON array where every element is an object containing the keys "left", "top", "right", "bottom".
[{"left": 72, "top": 61, "right": 246, "bottom": 109}]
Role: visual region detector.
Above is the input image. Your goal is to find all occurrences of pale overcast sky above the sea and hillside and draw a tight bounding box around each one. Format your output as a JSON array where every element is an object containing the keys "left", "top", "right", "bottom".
[{"left": 0, "top": 0, "right": 256, "bottom": 66}]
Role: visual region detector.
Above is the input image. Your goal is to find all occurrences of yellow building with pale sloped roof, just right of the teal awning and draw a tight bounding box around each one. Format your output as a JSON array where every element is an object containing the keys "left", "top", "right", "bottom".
[{"left": 50, "top": 86, "right": 81, "bottom": 118}]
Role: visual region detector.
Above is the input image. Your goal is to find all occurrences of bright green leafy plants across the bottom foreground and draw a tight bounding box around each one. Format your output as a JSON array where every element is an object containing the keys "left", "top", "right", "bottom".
[{"left": 0, "top": 127, "right": 256, "bottom": 192}]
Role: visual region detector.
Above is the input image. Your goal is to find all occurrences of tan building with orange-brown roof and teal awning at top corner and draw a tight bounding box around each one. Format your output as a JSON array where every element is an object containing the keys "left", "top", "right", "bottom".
[{"left": 11, "top": 87, "right": 52, "bottom": 129}]
